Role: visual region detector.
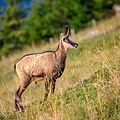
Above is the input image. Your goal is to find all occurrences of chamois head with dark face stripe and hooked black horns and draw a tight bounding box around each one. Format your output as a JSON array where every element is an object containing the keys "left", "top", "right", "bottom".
[{"left": 60, "top": 25, "right": 78, "bottom": 51}]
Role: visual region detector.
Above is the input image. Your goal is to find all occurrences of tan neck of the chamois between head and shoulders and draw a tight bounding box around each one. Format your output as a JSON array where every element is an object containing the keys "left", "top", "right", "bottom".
[{"left": 55, "top": 41, "right": 67, "bottom": 61}]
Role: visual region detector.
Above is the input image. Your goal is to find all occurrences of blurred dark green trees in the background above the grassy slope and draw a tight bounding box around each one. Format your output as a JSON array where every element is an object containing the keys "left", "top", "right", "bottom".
[{"left": 0, "top": 0, "right": 120, "bottom": 59}]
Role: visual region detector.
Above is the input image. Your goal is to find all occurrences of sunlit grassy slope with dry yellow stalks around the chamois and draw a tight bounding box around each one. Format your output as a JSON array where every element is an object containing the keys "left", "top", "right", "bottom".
[{"left": 0, "top": 18, "right": 120, "bottom": 120}]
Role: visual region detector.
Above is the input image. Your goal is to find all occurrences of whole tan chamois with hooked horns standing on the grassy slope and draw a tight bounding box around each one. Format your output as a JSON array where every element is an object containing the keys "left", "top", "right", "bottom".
[{"left": 14, "top": 25, "right": 78, "bottom": 111}]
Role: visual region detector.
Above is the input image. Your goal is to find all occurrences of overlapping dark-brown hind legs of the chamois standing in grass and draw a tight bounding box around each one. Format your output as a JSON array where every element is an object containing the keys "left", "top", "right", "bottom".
[{"left": 15, "top": 76, "right": 31, "bottom": 111}]
